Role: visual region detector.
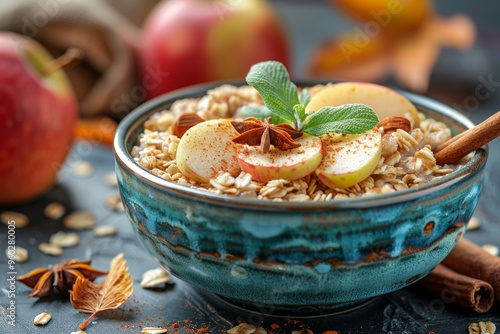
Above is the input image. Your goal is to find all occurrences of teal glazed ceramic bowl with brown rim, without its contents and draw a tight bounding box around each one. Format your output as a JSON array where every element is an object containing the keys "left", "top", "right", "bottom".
[{"left": 114, "top": 81, "right": 487, "bottom": 314}]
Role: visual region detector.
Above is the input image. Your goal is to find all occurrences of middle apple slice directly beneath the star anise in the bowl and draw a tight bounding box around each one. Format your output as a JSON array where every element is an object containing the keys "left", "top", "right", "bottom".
[{"left": 238, "top": 135, "right": 322, "bottom": 182}]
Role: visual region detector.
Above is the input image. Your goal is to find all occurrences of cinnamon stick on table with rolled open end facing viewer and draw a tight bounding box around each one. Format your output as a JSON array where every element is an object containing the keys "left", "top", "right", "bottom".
[{"left": 417, "top": 264, "right": 495, "bottom": 313}]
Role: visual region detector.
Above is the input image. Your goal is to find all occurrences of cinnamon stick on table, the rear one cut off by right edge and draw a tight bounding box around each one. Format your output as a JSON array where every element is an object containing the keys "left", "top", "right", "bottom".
[{"left": 442, "top": 238, "right": 500, "bottom": 301}]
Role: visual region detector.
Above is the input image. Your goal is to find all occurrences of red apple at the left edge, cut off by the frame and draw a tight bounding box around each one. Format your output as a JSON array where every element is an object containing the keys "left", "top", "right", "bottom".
[{"left": 0, "top": 32, "right": 78, "bottom": 204}]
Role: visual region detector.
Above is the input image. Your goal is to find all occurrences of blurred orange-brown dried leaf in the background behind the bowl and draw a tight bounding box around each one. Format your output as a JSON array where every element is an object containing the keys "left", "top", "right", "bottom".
[{"left": 308, "top": 13, "right": 476, "bottom": 92}]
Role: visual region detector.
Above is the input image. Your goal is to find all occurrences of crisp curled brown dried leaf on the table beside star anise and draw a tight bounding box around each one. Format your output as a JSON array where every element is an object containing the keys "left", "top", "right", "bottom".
[{"left": 70, "top": 254, "right": 134, "bottom": 329}]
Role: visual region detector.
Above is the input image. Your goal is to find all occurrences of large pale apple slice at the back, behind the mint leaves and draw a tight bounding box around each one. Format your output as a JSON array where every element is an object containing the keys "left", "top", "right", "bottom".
[{"left": 306, "top": 82, "right": 420, "bottom": 127}]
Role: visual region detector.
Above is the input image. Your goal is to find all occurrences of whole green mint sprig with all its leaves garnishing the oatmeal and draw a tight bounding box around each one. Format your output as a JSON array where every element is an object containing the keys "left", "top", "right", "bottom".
[{"left": 242, "top": 61, "right": 379, "bottom": 136}]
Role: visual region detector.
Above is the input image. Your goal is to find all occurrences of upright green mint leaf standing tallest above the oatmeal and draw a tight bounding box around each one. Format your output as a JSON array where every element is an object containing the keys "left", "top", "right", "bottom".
[{"left": 246, "top": 61, "right": 300, "bottom": 123}]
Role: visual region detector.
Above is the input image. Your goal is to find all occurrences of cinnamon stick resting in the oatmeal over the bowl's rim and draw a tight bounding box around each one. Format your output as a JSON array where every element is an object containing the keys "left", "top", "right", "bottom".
[{"left": 434, "top": 111, "right": 500, "bottom": 166}]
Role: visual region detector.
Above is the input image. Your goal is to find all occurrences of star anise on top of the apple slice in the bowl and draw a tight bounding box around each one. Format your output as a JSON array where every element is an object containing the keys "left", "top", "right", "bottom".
[{"left": 231, "top": 117, "right": 303, "bottom": 153}]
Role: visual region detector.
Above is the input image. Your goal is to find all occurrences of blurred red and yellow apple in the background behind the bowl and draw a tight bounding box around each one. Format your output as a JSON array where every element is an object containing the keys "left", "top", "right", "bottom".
[{"left": 140, "top": 0, "right": 289, "bottom": 98}]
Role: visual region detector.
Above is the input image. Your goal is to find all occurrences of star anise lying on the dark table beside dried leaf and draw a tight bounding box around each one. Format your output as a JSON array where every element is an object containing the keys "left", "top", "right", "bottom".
[{"left": 17, "top": 259, "right": 108, "bottom": 297}]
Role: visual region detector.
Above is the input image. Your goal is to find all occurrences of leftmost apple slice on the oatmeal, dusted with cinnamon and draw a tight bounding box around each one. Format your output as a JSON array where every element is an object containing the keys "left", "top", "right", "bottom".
[{"left": 175, "top": 119, "right": 240, "bottom": 183}]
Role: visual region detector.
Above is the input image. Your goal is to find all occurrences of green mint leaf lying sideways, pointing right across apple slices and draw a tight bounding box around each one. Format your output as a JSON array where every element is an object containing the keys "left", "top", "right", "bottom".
[{"left": 302, "top": 104, "right": 379, "bottom": 136}]
